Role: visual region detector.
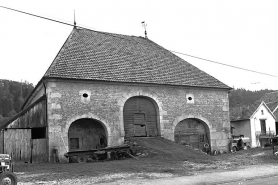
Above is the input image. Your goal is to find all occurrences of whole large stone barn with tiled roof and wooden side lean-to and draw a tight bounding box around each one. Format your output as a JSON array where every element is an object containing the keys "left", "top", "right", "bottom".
[{"left": 0, "top": 27, "right": 231, "bottom": 162}]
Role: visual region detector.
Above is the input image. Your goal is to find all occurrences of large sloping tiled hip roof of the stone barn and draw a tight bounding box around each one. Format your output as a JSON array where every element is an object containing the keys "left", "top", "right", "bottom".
[{"left": 44, "top": 28, "right": 231, "bottom": 89}]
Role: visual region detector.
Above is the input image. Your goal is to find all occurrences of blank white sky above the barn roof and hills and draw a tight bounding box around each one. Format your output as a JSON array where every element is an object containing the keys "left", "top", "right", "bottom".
[{"left": 0, "top": 0, "right": 278, "bottom": 91}]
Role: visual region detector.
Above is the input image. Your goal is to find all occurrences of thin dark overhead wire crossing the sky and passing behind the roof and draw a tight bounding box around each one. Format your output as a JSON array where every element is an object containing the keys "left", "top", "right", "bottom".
[{"left": 0, "top": 6, "right": 278, "bottom": 78}]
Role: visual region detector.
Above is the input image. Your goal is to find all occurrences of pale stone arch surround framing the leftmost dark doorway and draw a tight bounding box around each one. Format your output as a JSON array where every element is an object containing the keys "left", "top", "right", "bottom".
[{"left": 63, "top": 113, "right": 112, "bottom": 148}]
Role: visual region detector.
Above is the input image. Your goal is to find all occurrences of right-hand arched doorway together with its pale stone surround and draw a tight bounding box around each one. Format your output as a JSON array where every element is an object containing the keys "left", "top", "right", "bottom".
[{"left": 172, "top": 115, "right": 211, "bottom": 149}]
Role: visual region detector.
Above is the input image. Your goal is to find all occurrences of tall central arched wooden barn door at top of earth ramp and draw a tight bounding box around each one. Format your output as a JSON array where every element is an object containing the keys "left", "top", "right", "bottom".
[{"left": 123, "top": 96, "right": 159, "bottom": 137}]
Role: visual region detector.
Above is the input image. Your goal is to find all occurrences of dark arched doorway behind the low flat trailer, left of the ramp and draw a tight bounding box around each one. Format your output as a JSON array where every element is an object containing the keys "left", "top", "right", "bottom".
[{"left": 68, "top": 118, "right": 107, "bottom": 151}]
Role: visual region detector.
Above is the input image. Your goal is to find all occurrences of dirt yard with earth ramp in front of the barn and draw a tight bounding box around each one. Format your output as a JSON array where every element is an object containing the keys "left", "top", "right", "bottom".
[{"left": 15, "top": 139, "right": 278, "bottom": 185}]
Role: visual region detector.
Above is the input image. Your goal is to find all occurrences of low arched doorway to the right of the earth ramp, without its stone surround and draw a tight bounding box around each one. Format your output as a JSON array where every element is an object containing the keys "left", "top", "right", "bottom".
[{"left": 174, "top": 118, "right": 210, "bottom": 149}]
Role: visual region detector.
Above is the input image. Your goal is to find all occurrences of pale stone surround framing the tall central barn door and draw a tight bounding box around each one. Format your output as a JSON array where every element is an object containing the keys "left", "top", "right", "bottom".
[{"left": 118, "top": 91, "right": 167, "bottom": 136}]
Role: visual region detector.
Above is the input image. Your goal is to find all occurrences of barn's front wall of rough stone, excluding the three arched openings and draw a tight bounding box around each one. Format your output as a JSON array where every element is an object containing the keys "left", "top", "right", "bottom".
[{"left": 46, "top": 80, "right": 230, "bottom": 159}]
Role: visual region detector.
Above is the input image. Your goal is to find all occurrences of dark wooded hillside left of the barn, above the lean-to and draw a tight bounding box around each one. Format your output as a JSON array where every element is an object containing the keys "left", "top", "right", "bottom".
[{"left": 0, "top": 79, "right": 34, "bottom": 124}]
